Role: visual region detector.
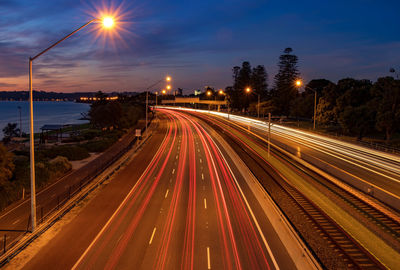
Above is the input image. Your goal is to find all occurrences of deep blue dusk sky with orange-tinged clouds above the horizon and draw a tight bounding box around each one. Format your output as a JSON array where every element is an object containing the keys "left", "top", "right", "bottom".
[{"left": 0, "top": 0, "right": 400, "bottom": 93}]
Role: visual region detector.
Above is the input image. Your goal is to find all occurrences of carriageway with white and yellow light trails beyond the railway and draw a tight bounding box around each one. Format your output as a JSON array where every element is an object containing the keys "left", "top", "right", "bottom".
[{"left": 177, "top": 109, "right": 400, "bottom": 210}]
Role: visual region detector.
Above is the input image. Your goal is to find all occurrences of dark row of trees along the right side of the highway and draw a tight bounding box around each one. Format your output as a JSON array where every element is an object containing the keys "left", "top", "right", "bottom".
[{"left": 216, "top": 48, "right": 400, "bottom": 147}]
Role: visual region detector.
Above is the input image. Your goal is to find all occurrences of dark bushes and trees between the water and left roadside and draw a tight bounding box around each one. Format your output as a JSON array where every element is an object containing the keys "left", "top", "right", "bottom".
[{"left": 0, "top": 95, "right": 144, "bottom": 210}]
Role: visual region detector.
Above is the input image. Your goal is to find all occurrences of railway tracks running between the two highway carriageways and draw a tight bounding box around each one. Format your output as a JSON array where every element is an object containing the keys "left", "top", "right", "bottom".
[{"left": 197, "top": 111, "right": 388, "bottom": 269}]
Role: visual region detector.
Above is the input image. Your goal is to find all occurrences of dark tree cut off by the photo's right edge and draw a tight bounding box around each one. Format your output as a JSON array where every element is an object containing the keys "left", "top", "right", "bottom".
[{"left": 371, "top": 77, "right": 400, "bottom": 142}]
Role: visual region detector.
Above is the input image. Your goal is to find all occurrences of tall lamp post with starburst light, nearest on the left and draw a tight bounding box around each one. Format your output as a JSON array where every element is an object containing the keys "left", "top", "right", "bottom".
[{"left": 29, "top": 17, "right": 114, "bottom": 232}]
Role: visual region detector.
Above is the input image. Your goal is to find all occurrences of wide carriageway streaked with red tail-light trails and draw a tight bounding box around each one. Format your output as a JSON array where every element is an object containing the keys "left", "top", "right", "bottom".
[{"left": 18, "top": 109, "right": 295, "bottom": 269}]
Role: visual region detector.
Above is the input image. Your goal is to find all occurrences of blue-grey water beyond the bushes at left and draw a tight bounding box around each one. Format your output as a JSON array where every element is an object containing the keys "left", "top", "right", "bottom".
[{"left": 0, "top": 101, "right": 90, "bottom": 139}]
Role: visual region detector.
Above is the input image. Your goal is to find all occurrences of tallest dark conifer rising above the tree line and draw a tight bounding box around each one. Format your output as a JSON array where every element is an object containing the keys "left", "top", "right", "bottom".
[{"left": 273, "top": 48, "right": 300, "bottom": 116}]
